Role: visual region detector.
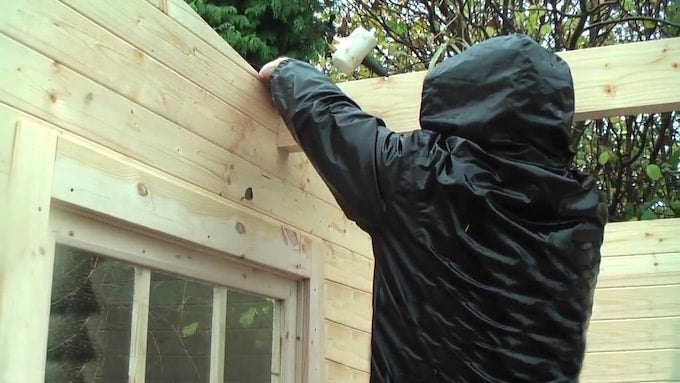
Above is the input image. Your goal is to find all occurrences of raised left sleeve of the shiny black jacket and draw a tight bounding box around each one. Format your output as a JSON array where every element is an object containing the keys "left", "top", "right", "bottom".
[{"left": 270, "top": 59, "right": 412, "bottom": 232}]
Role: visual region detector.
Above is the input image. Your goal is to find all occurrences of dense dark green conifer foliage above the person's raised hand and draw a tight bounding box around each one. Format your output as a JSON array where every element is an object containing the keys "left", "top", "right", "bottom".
[{"left": 186, "top": 0, "right": 328, "bottom": 68}]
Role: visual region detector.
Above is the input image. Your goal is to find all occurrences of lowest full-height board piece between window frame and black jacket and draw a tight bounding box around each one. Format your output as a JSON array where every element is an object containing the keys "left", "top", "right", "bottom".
[{"left": 324, "top": 320, "right": 371, "bottom": 372}]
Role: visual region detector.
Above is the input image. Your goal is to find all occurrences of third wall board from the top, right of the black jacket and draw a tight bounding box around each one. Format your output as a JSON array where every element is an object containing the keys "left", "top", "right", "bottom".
[{"left": 592, "top": 285, "right": 680, "bottom": 320}]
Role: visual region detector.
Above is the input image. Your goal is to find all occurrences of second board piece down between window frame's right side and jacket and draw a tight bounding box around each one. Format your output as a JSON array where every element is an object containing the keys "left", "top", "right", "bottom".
[{"left": 324, "top": 281, "right": 373, "bottom": 332}]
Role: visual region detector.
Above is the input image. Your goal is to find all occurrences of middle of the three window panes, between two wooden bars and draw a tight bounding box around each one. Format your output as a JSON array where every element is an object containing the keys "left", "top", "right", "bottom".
[{"left": 146, "top": 272, "right": 213, "bottom": 383}]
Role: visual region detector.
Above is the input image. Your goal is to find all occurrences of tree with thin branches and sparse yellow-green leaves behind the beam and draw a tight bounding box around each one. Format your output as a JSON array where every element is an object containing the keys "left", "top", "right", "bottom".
[{"left": 318, "top": 0, "right": 680, "bottom": 221}]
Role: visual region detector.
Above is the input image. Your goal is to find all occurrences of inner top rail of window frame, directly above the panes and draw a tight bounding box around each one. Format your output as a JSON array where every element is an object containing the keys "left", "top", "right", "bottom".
[{"left": 50, "top": 201, "right": 295, "bottom": 299}]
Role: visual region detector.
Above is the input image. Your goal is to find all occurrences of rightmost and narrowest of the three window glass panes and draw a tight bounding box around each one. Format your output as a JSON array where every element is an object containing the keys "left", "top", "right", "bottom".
[{"left": 224, "top": 290, "right": 274, "bottom": 383}]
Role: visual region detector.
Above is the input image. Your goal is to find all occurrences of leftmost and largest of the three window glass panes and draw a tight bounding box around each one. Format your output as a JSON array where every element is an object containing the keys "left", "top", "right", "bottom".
[{"left": 45, "top": 245, "right": 134, "bottom": 383}]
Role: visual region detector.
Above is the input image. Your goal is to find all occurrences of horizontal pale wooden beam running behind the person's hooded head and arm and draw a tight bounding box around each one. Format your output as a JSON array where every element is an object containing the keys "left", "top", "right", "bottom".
[{"left": 279, "top": 38, "right": 680, "bottom": 152}]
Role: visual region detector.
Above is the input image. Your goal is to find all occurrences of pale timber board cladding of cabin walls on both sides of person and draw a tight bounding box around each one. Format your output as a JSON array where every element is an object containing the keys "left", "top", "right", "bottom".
[{"left": 0, "top": 0, "right": 680, "bottom": 382}]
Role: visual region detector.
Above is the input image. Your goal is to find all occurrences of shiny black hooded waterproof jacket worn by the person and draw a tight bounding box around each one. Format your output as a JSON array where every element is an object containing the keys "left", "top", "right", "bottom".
[{"left": 270, "top": 35, "right": 606, "bottom": 383}]
